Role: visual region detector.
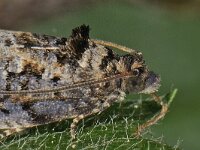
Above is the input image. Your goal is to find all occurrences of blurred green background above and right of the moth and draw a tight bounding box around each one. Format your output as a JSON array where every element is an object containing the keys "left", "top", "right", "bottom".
[{"left": 0, "top": 1, "right": 200, "bottom": 150}]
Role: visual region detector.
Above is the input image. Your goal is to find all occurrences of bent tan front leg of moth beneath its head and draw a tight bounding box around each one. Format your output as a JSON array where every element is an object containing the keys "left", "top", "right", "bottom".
[{"left": 134, "top": 93, "right": 168, "bottom": 137}]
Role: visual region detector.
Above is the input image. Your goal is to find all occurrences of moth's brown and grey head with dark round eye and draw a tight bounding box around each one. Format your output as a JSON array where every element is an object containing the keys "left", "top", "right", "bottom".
[{"left": 122, "top": 52, "right": 160, "bottom": 94}]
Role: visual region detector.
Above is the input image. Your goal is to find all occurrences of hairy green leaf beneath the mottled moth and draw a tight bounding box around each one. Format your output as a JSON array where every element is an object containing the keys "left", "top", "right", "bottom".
[{"left": 0, "top": 89, "right": 177, "bottom": 150}]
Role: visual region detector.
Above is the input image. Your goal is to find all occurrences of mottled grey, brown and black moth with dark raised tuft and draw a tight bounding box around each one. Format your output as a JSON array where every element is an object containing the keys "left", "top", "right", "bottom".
[{"left": 0, "top": 25, "right": 167, "bottom": 138}]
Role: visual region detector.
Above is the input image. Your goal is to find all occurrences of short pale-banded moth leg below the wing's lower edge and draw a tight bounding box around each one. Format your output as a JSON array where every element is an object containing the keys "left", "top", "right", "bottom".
[{"left": 70, "top": 115, "right": 85, "bottom": 140}]
